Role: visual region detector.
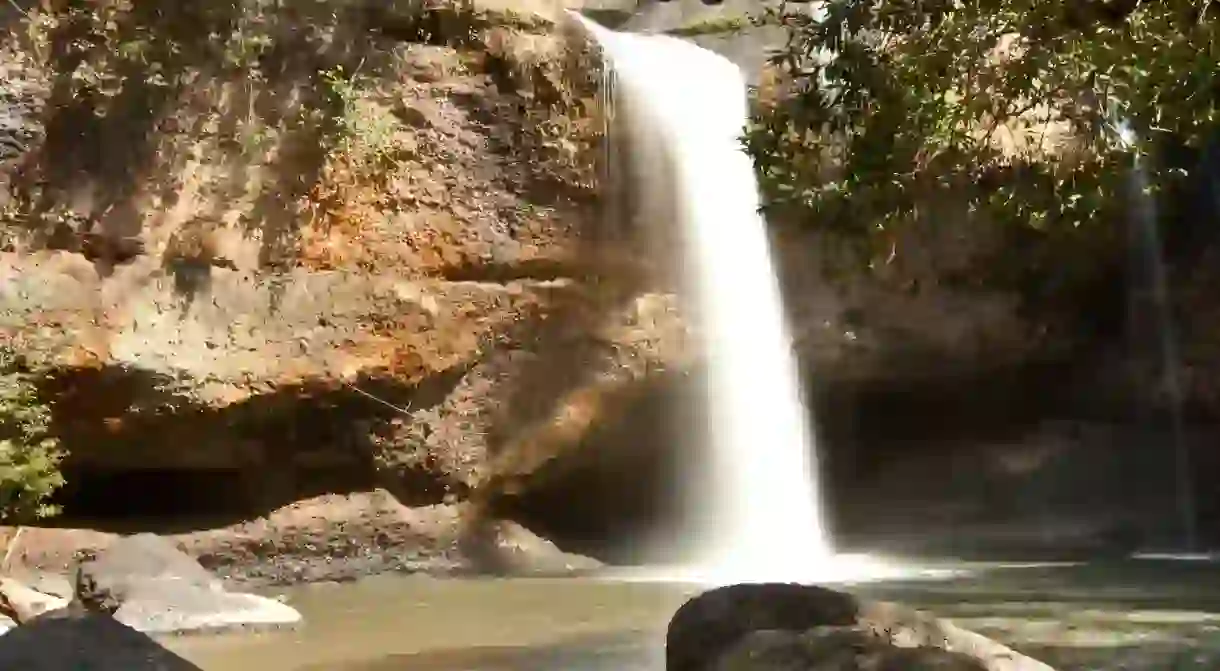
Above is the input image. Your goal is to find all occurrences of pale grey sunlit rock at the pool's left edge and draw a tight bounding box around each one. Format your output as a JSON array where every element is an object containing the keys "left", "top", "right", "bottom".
[{"left": 77, "top": 534, "right": 301, "bottom": 633}]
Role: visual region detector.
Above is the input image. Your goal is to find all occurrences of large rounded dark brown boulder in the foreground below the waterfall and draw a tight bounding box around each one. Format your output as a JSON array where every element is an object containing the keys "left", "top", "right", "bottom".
[{"left": 665, "top": 583, "right": 1053, "bottom": 671}]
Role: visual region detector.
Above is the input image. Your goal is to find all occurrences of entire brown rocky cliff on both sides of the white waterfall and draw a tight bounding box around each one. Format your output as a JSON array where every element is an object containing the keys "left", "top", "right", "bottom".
[{"left": 0, "top": 0, "right": 1215, "bottom": 575}]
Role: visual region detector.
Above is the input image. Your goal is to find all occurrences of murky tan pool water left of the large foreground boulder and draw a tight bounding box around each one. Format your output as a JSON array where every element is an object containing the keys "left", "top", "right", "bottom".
[{"left": 176, "top": 577, "right": 698, "bottom": 671}]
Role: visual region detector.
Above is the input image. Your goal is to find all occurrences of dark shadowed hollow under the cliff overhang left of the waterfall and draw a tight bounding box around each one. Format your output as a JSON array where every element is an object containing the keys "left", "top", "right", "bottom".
[{"left": 40, "top": 367, "right": 466, "bottom": 533}]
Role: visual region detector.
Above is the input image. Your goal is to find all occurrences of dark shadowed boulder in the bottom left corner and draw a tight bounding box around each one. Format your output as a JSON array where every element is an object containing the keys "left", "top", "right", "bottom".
[{"left": 0, "top": 614, "right": 203, "bottom": 671}]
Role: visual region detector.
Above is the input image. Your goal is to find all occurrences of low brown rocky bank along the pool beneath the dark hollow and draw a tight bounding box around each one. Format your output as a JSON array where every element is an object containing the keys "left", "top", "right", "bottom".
[{"left": 0, "top": 490, "right": 599, "bottom": 589}]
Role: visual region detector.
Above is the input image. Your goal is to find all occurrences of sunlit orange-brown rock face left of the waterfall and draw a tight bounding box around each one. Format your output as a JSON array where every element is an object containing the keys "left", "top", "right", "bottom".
[{"left": 0, "top": 0, "right": 691, "bottom": 551}]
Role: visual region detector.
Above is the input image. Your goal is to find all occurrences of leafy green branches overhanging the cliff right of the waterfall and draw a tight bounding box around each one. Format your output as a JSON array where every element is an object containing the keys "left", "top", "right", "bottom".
[{"left": 745, "top": 0, "right": 1220, "bottom": 270}]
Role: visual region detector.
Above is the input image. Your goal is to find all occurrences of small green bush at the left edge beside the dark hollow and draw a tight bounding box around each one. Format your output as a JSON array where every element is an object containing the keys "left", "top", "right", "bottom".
[{"left": 0, "top": 348, "right": 63, "bottom": 523}]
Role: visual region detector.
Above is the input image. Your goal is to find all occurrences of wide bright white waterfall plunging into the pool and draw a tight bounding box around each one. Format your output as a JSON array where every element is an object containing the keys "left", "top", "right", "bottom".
[{"left": 570, "top": 18, "right": 831, "bottom": 581}]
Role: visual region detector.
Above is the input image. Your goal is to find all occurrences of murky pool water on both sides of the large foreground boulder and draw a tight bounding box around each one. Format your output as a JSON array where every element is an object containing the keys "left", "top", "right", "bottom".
[{"left": 168, "top": 560, "right": 1220, "bottom": 671}]
